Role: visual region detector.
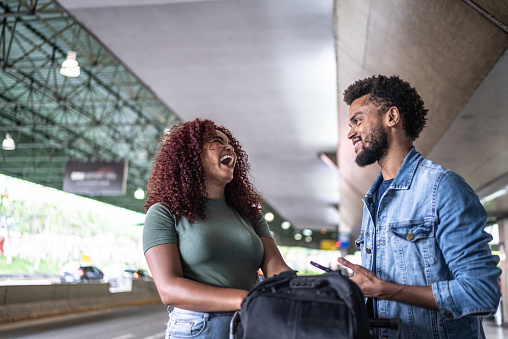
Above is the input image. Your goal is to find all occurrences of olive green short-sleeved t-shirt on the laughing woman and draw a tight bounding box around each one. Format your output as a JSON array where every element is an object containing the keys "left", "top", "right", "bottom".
[{"left": 143, "top": 198, "right": 272, "bottom": 290}]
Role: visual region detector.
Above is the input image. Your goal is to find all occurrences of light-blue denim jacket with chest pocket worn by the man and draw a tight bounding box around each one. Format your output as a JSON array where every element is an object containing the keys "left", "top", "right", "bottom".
[{"left": 356, "top": 147, "right": 501, "bottom": 339}]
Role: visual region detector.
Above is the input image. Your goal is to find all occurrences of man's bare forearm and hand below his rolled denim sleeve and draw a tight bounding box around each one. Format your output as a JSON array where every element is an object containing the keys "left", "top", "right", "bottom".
[{"left": 337, "top": 258, "right": 438, "bottom": 310}]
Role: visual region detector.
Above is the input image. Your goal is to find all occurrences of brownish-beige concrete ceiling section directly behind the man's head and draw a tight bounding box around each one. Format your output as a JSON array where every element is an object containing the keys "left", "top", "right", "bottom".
[{"left": 336, "top": 0, "right": 508, "bottom": 242}]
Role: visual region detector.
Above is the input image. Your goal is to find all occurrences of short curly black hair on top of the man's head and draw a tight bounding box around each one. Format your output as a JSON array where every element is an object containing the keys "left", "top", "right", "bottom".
[{"left": 344, "top": 75, "right": 429, "bottom": 141}]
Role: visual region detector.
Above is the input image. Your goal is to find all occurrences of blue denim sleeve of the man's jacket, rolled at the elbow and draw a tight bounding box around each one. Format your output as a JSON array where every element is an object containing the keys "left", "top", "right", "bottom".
[{"left": 432, "top": 172, "right": 501, "bottom": 318}]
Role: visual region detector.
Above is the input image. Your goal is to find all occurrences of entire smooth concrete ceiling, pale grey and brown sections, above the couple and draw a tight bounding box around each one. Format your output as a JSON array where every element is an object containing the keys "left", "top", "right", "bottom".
[{"left": 2, "top": 0, "right": 508, "bottom": 250}]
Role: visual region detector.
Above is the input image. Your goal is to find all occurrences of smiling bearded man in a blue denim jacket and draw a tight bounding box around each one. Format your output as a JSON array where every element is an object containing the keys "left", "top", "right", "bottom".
[{"left": 338, "top": 75, "right": 501, "bottom": 339}]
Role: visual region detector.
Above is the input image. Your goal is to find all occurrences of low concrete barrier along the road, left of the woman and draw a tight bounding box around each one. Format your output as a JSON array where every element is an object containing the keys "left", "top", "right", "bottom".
[{"left": 0, "top": 280, "right": 161, "bottom": 324}]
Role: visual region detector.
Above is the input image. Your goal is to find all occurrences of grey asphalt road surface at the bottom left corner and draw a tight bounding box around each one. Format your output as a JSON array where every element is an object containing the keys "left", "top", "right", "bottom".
[{"left": 0, "top": 304, "right": 168, "bottom": 339}]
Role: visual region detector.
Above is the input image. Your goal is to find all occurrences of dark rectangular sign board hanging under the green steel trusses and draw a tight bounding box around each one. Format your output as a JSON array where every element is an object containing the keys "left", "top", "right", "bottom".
[{"left": 63, "top": 160, "right": 127, "bottom": 196}]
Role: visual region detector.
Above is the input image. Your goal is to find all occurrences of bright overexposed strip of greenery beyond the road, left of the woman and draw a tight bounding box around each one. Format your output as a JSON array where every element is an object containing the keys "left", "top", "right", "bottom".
[{"left": 0, "top": 174, "right": 146, "bottom": 273}]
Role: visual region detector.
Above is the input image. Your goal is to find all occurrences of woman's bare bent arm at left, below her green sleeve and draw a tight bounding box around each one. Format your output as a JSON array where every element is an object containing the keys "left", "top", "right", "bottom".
[{"left": 145, "top": 244, "right": 247, "bottom": 312}]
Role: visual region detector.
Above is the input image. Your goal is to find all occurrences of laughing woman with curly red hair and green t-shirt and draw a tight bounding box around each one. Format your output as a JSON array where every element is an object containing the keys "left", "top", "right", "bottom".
[{"left": 143, "top": 119, "right": 290, "bottom": 339}]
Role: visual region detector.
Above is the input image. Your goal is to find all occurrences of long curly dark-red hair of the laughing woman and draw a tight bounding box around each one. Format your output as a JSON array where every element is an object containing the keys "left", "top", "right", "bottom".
[{"left": 143, "top": 119, "right": 261, "bottom": 224}]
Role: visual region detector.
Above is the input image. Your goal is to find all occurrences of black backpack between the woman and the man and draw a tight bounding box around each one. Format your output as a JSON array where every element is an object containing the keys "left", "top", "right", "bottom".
[{"left": 230, "top": 271, "right": 371, "bottom": 339}]
